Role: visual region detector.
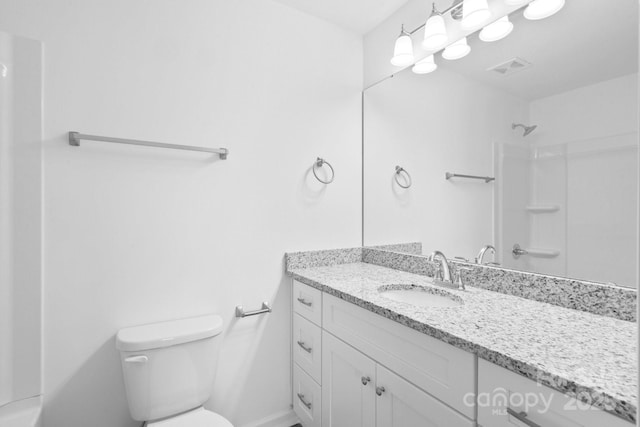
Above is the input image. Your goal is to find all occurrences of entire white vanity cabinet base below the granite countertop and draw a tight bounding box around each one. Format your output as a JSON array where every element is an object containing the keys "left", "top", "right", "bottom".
[{"left": 292, "top": 281, "right": 632, "bottom": 427}]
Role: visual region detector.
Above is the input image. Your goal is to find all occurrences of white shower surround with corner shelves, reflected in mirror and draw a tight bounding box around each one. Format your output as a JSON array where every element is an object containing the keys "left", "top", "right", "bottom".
[{"left": 494, "top": 110, "right": 638, "bottom": 286}]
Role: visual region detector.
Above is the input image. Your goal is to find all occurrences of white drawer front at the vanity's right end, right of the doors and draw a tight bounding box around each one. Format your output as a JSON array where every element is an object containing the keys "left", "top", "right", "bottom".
[{"left": 478, "top": 360, "right": 633, "bottom": 427}]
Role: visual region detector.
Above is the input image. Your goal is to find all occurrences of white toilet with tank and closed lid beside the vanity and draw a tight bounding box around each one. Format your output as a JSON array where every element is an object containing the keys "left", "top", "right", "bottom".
[{"left": 116, "top": 315, "right": 233, "bottom": 427}]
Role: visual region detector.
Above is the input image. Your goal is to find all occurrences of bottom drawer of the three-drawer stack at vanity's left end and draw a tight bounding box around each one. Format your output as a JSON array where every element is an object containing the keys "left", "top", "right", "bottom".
[{"left": 293, "top": 363, "right": 322, "bottom": 427}]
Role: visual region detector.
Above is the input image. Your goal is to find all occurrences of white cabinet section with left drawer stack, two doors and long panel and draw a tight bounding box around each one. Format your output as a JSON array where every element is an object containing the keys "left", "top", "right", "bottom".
[{"left": 292, "top": 281, "right": 476, "bottom": 427}]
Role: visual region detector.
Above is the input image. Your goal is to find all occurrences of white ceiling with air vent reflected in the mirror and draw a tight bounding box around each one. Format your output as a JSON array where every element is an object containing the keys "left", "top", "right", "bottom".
[{"left": 432, "top": 0, "right": 638, "bottom": 99}]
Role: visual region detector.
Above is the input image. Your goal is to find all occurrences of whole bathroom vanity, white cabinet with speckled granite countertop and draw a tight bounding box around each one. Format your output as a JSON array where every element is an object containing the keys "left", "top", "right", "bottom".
[{"left": 287, "top": 249, "right": 637, "bottom": 427}]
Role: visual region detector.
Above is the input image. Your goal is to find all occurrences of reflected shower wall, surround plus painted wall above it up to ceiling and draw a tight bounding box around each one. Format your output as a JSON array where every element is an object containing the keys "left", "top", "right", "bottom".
[{"left": 497, "top": 74, "right": 638, "bottom": 287}]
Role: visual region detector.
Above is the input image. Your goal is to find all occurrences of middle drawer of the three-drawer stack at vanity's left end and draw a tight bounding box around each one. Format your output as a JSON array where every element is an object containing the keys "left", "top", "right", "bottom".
[{"left": 293, "top": 313, "right": 322, "bottom": 384}]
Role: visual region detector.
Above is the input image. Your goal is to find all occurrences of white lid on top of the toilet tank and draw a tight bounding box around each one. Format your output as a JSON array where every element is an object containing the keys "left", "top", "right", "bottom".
[{"left": 116, "top": 314, "right": 222, "bottom": 351}]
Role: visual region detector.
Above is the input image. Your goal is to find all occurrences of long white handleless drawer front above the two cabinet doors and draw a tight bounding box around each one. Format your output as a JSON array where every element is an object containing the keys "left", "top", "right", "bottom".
[{"left": 323, "top": 294, "right": 476, "bottom": 420}]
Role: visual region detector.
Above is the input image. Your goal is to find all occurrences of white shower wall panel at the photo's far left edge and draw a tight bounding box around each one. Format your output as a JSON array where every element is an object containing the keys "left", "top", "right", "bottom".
[{"left": 0, "top": 32, "right": 42, "bottom": 406}]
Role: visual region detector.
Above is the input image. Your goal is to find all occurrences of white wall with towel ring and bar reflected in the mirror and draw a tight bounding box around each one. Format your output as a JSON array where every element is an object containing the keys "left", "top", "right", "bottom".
[{"left": 364, "top": 67, "right": 528, "bottom": 259}]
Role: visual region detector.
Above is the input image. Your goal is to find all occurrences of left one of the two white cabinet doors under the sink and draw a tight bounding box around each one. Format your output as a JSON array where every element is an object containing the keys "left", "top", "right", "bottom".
[{"left": 322, "top": 332, "right": 376, "bottom": 427}]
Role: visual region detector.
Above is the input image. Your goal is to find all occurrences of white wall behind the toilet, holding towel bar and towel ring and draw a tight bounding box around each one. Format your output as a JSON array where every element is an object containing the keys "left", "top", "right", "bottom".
[{"left": 0, "top": 0, "right": 362, "bottom": 427}]
